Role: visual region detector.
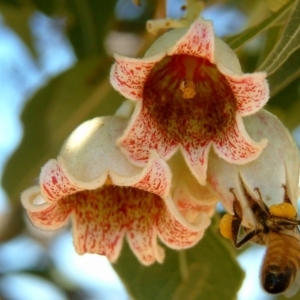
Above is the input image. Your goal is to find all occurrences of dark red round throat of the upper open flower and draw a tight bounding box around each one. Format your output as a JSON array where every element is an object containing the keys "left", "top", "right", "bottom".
[{"left": 143, "top": 55, "right": 237, "bottom": 143}]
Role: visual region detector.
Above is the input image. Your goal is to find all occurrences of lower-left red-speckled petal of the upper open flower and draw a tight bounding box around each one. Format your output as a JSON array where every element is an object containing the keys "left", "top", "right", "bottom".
[{"left": 119, "top": 103, "right": 177, "bottom": 166}]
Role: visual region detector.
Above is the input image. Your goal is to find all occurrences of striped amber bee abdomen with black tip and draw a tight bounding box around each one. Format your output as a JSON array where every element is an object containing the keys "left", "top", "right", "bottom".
[{"left": 261, "top": 233, "right": 300, "bottom": 294}]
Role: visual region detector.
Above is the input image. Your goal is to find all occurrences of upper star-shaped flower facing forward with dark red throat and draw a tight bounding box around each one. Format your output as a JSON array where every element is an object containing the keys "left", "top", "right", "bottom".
[{"left": 110, "top": 19, "right": 269, "bottom": 184}]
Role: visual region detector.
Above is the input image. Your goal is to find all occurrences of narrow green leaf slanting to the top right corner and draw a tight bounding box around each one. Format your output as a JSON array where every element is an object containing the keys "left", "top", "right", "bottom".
[{"left": 225, "top": 0, "right": 293, "bottom": 50}]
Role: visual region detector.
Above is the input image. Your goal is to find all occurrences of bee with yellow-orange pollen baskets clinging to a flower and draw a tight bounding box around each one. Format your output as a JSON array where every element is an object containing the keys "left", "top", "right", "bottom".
[{"left": 220, "top": 178, "right": 300, "bottom": 297}]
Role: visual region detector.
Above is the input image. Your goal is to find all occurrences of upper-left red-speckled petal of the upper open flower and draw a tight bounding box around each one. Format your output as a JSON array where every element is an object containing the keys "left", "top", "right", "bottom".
[{"left": 110, "top": 55, "right": 156, "bottom": 100}]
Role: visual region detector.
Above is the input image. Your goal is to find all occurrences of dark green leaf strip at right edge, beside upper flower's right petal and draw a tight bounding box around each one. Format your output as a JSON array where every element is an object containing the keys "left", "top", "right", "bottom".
[{"left": 268, "top": 49, "right": 300, "bottom": 96}]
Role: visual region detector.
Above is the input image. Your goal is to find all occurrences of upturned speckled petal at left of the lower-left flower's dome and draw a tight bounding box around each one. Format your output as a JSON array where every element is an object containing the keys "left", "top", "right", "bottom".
[{"left": 40, "top": 159, "right": 82, "bottom": 201}]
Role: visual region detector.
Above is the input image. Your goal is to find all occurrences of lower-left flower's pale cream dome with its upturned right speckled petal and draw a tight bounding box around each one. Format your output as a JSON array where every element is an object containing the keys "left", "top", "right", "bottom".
[{"left": 58, "top": 117, "right": 171, "bottom": 197}]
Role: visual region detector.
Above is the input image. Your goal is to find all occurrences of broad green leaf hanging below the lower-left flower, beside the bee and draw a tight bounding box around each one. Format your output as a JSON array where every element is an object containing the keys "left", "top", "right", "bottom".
[{"left": 113, "top": 220, "right": 243, "bottom": 300}]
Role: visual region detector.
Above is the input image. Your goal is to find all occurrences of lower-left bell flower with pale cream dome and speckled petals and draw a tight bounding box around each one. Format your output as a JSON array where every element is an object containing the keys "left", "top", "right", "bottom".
[{"left": 21, "top": 116, "right": 215, "bottom": 265}]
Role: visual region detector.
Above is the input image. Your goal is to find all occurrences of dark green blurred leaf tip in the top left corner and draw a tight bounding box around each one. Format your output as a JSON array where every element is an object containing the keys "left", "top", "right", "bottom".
[{"left": 0, "top": 3, "right": 37, "bottom": 57}]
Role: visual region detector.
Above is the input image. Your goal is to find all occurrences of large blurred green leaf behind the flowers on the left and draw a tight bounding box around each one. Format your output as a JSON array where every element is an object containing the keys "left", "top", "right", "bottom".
[{"left": 2, "top": 58, "right": 122, "bottom": 201}]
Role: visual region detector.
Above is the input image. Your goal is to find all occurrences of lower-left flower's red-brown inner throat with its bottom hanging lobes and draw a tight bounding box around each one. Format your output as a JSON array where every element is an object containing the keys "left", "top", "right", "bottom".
[{"left": 70, "top": 186, "right": 165, "bottom": 265}]
